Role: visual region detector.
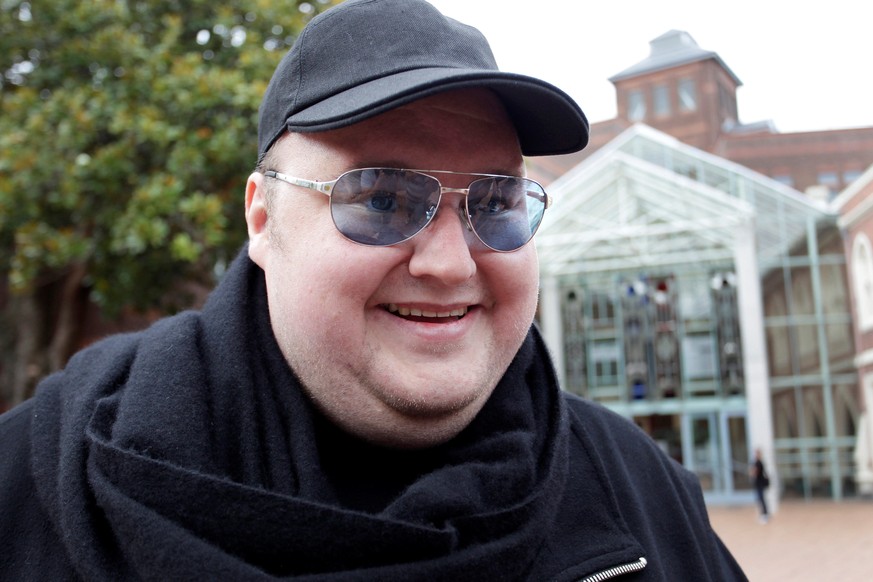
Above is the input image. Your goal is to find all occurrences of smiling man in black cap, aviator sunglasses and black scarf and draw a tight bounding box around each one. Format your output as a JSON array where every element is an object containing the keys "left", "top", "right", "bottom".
[{"left": 0, "top": 0, "right": 744, "bottom": 580}]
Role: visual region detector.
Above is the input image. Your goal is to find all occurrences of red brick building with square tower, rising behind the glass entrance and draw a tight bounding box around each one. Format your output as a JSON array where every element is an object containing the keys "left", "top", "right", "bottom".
[{"left": 531, "top": 30, "right": 873, "bottom": 200}]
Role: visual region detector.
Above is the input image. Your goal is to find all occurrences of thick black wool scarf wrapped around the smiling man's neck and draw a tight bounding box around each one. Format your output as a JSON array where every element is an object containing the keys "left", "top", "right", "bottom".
[{"left": 32, "top": 249, "right": 568, "bottom": 581}]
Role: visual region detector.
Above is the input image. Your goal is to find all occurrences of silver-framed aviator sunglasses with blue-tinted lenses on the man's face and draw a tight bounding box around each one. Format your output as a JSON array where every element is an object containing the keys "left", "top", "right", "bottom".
[{"left": 264, "top": 168, "right": 551, "bottom": 252}]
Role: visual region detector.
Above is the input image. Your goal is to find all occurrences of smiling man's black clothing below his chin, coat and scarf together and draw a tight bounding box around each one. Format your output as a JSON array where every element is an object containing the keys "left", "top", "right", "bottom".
[{"left": 0, "top": 255, "right": 745, "bottom": 581}]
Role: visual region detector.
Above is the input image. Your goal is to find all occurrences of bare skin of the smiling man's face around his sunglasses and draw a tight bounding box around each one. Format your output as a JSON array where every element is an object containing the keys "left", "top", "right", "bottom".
[{"left": 246, "top": 90, "right": 538, "bottom": 448}]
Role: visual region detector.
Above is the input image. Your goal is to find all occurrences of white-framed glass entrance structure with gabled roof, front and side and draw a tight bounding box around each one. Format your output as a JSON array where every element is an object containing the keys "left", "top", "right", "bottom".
[{"left": 536, "top": 125, "right": 859, "bottom": 499}]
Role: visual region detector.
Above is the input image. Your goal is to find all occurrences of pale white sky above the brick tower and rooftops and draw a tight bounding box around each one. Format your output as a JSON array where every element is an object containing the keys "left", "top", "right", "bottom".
[{"left": 430, "top": 0, "right": 873, "bottom": 133}]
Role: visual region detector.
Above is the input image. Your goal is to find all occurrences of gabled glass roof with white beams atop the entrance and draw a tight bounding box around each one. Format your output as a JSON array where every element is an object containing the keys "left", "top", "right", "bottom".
[{"left": 537, "top": 125, "right": 836, "bottom": 276}]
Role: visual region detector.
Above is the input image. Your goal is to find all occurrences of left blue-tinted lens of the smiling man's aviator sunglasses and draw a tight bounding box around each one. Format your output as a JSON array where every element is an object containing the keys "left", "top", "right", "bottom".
[{"left": 330, "top": 168, "right": 440, "bottom": 246}]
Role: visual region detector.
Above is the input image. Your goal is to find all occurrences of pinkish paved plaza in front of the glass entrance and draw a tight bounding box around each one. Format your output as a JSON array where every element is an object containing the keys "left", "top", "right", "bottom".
[{"left": 709, "top": 500, "right": 873, "bottom": 582}]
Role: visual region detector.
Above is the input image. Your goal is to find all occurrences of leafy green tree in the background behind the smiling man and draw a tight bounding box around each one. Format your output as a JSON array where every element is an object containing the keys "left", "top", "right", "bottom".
[{"left": 0, "top": 0, "right": 336, "bottom": 407}]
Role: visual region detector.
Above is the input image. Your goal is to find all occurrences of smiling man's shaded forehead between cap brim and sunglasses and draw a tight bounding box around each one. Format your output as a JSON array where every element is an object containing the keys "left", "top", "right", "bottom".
[{"left": 277, "top": 89, "right": 523, "bottom": 179}]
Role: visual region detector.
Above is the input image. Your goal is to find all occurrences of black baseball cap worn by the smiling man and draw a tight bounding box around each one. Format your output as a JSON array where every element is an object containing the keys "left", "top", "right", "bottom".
[{"left": 258, "top": 0, "right": 588, "bottom": 156}]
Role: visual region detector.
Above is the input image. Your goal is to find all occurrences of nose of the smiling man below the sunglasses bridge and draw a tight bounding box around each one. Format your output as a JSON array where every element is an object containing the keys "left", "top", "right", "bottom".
[{"left": 409, "top": 197, "right": 476, "bottom": 285}]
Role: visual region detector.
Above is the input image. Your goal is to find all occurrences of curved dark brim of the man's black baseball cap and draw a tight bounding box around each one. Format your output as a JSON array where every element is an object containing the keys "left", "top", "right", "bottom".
[{"left": 286, "top": 68, "right": 589, "bottom": 156}]
